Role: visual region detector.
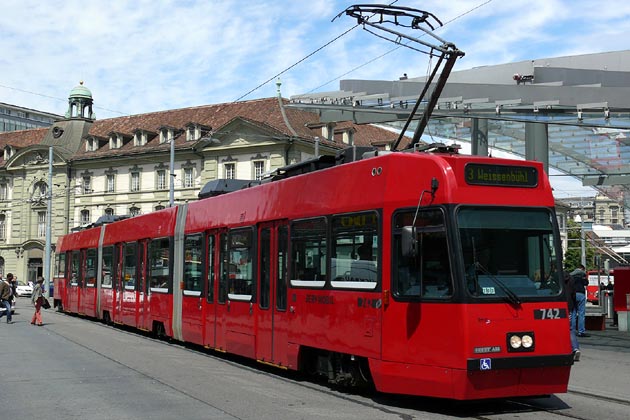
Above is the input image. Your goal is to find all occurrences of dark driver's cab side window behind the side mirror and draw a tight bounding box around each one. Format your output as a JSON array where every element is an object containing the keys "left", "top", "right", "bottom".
[{"left": 392, "top": 209, "right": 453, "bottom": 299}]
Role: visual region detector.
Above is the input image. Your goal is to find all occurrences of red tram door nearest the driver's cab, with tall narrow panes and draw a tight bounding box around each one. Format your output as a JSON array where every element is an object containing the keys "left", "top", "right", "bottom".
[{"left": 256, "top": 222, "right": 288, "bottom": 366}]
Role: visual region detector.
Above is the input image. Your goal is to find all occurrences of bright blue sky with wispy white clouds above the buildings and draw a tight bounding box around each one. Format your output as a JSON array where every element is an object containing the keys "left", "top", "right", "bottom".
[{"left": 0, "top": 0, "right": 630, "bottom": 196}]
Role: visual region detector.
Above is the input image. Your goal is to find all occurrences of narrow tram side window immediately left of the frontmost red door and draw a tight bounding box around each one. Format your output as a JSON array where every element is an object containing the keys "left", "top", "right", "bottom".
[{"left": 228, "top": 228, "right": 256, "bottom": 301}]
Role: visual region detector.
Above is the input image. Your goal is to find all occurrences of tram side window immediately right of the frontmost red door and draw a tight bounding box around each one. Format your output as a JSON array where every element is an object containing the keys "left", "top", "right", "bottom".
[{"left": 291, "top": 217, "right": 327, "bottom": 287}]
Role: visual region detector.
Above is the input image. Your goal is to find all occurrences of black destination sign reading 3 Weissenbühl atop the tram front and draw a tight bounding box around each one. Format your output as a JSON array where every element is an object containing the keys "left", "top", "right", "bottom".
[{"left": 466, "top": 163, "right": 538, "bottom": 188}]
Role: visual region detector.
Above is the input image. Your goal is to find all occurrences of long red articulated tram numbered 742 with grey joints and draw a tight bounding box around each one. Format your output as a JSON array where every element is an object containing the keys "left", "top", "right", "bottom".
[{"left": 54, "top": 147, "right": 573, "bottom": 400}]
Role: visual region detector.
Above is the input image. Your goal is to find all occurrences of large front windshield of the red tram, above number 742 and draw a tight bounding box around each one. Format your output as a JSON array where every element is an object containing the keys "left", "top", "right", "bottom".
[{"left": 457, "top": 207, "right": 561, "bottom": 302}]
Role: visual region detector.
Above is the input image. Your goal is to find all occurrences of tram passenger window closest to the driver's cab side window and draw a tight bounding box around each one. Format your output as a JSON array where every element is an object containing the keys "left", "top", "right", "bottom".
[{"left": 330, "top": 212, "right": 379, "bottom": 289}]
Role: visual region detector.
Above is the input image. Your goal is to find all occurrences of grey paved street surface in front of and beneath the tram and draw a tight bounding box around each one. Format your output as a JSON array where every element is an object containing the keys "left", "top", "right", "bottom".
[{"left": 0, "top": 298, "right": 630, "bottom": 420}]
